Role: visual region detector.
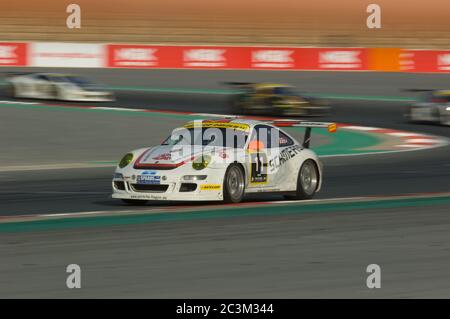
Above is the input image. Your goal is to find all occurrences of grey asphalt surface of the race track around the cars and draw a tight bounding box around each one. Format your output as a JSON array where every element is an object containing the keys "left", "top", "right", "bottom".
[{"left": 0, "top": 69, "right": 450, "bottom": 298}]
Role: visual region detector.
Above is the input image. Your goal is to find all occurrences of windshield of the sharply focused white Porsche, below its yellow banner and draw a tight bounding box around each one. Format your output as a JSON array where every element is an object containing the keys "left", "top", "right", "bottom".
[{"left": 162, "top": 127, "right": 248, "bottom": 148}]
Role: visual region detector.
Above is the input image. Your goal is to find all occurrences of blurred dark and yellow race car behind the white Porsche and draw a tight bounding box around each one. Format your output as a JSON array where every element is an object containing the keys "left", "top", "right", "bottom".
[{"left": 226, "top": 82, "right": 330, "bottom": 116}]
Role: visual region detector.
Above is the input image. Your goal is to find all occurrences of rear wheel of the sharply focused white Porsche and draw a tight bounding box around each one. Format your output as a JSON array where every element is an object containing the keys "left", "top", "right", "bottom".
[{"left": 285, "top": 160, "right": 320, "bottom": 200}]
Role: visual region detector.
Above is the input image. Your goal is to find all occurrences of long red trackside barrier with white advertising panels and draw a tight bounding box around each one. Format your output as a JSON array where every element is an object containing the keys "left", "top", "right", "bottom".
[{"left": 0, "top": 42, "right": 450, "bottom": 72}]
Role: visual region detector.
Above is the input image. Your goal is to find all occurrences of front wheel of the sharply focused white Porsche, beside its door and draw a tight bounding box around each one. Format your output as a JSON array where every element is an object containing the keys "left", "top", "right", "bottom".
[{"left": 223, "top": 164, "right": 245, "bottom": 203}]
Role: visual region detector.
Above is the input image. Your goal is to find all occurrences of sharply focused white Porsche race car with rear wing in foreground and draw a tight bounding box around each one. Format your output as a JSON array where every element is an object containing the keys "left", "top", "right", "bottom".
[{"left": 112, "top": 119, "right": 336, "bottom": 204}]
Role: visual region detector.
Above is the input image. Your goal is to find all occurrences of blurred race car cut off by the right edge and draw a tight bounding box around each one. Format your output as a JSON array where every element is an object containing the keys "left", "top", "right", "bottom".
[{"left": 405, "top": 89, "right": 450, "bottom": 125}]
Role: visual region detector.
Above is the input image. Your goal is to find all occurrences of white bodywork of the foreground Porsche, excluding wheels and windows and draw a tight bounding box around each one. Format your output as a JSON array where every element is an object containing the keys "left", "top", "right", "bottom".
[{"left": 112, "top": 120, "right": 322, "bottom": 201}]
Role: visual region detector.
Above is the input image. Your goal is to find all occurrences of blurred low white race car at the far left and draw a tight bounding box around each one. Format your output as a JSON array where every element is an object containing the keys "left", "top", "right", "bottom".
[{"left": 6, "top": 73, "right": 115, "bottom": 102}]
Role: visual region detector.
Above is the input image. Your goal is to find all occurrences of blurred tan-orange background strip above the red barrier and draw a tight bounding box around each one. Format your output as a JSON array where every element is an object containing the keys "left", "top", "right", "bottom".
[{"left": 0, "top": 0, "right": 450, "bottom": 49}]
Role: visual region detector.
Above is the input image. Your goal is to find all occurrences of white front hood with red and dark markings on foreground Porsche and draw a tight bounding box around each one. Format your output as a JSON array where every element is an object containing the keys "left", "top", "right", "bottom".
[{"left": 134, "top": 145, "right": 226, "bottom": 169}]
